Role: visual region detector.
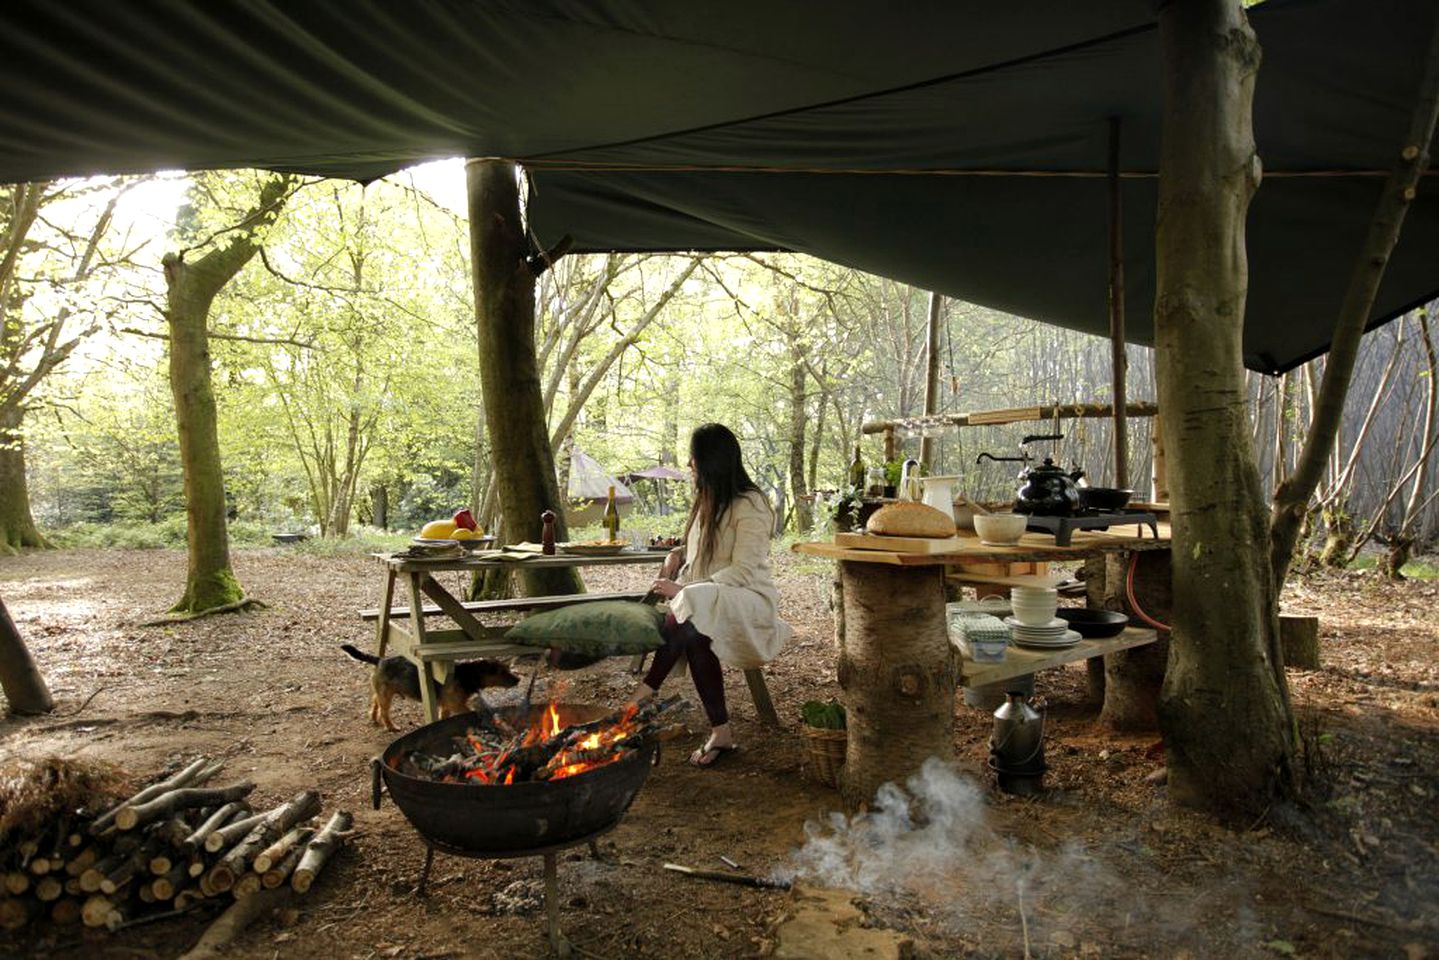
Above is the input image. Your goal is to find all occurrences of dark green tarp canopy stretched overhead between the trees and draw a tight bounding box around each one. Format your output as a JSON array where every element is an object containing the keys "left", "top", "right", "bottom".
[{"left": 0, "top": 0, "right": 1439, "bottom": 373}]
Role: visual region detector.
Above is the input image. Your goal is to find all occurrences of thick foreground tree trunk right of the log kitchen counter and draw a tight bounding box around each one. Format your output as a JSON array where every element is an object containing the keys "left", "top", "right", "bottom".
[{"left": 1154, "top": 0, "right": 1294, "bottom": 819}]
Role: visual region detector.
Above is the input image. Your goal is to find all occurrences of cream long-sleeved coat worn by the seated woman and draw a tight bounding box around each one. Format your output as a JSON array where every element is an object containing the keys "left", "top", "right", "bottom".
[{"left": 669, "top": 491, "right": 791, "bottom": 669}]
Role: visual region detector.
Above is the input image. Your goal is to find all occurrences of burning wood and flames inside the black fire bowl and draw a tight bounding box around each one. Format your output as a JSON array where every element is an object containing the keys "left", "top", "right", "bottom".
[{"left": 393, "top": 697, "right": 688, "bottom": 784}]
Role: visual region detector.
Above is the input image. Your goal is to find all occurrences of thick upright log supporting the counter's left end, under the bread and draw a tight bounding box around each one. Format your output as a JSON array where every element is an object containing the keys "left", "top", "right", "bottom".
[{"left": 839, "top": 560, "right": 958, "bottom": 807}]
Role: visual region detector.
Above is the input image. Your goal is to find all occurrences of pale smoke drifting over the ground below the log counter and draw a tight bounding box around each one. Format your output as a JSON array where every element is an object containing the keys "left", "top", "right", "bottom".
[{"left": 774, "top": 757, "right": 1233, "bottom": 956}]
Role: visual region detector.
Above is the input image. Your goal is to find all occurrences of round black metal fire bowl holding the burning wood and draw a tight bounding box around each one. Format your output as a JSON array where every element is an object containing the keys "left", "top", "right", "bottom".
[{"left": 370, "top": 704, "right": 656, "bottom": 859}]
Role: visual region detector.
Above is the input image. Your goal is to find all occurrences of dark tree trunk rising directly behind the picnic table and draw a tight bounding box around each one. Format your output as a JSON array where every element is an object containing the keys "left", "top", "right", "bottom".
[{"left": 465, "top": 160, "right": 584, "bottom": 596}]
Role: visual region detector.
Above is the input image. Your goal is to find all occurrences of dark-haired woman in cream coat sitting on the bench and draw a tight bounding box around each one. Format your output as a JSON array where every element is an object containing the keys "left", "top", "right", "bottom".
[{"left": 635, "top": 423, "right": 790, "bottom": 767}]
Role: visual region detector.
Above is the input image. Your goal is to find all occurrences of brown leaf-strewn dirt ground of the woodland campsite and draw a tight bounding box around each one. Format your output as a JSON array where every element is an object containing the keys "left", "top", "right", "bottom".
[{"left": 0, "top": 548, "right": 1439, "bottom": 960}]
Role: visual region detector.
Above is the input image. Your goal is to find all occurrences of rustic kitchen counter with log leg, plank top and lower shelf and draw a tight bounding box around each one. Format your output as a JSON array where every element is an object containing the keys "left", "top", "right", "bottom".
[{"left": 794, "top": 524, "right": 1168, "bottom": 806}]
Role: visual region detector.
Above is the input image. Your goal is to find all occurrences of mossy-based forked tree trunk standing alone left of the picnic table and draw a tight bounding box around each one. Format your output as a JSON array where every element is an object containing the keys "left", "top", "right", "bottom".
[{"left": 163, "top": 177, "right": 291, "bottom": 613}]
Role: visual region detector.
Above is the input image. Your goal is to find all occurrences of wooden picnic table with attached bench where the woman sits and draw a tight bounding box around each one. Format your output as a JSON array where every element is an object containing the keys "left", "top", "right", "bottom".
[{"left": 360, "top": 544, "right": 778, "bottom": 725}]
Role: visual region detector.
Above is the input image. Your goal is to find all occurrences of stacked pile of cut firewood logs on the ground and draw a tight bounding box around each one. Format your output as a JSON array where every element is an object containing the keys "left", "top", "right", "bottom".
[{"left": 0, "top": 757, "right": 351, "bottom": 931}]
